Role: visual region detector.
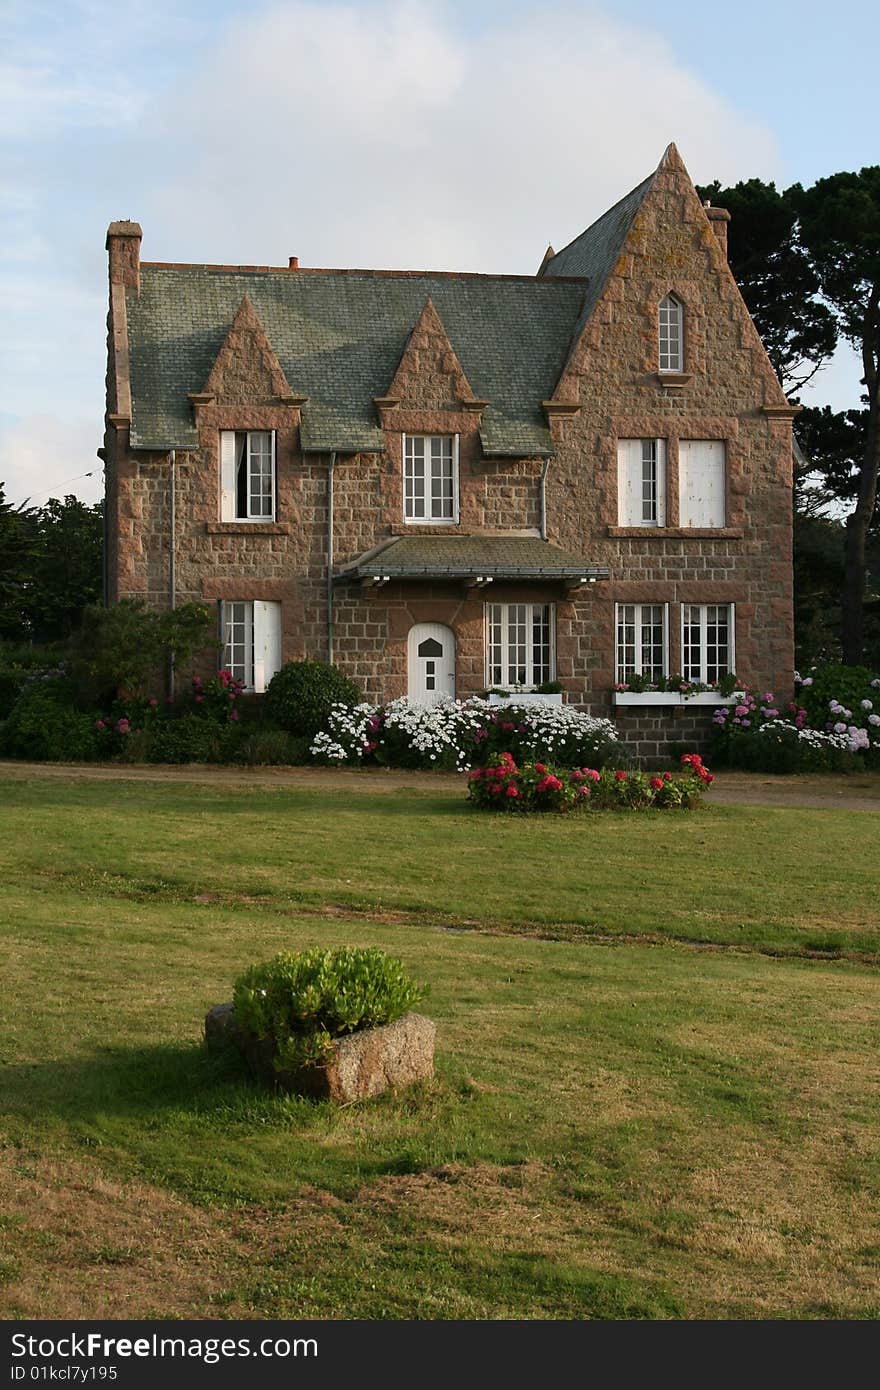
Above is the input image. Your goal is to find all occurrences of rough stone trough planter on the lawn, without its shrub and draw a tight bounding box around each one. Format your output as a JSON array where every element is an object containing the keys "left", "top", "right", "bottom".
[{"left": 204, "top": 1004, "right": 437, "bottom": 1105}]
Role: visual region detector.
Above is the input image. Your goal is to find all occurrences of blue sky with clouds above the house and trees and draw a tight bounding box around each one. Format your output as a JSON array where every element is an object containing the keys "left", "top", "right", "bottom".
[{"left": 0, "top": 0, "right": 880, "bottom": 505}]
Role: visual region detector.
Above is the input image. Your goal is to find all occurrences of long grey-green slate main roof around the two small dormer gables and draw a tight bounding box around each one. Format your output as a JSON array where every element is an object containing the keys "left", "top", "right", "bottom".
[{"left": 127, "top": 261, "right": 585, "bottom": 457}]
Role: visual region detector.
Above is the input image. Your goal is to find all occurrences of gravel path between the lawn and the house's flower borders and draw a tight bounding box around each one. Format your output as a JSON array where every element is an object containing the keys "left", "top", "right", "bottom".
[{"left": 0, "top": 762, "right": 880, "bottom": 812}]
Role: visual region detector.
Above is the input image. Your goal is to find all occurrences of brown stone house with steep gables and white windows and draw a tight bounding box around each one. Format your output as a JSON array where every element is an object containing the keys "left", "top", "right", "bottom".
[{"left": 101, "top": 145, "right": 795, "bottom": 753}]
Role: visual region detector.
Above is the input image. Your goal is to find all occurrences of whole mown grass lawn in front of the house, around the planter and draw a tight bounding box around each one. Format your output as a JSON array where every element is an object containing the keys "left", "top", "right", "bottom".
[{"left": 0, "top": 778, "right": 880, "bottom": 1318}]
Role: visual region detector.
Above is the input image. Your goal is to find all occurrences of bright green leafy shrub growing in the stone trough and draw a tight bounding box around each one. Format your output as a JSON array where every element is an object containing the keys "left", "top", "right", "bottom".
[{"left": 234, "top": 947, "right": 425, "bottom": 1072}]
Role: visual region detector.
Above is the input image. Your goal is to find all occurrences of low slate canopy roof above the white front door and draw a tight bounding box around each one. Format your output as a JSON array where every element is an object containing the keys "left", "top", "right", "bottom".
[{"left": 335, "top": 535, "right": 609, "bottom": 581}]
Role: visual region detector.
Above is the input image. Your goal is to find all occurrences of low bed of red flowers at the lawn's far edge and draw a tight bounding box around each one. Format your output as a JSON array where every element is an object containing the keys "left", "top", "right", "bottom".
[{"left": 467, "top": 753, "right": 715, "bottom": 812}]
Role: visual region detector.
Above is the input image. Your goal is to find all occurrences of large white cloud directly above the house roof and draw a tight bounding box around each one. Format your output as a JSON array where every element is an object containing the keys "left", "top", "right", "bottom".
[{"left": 147, "top": 0, "right": 777, "bottom": 272}]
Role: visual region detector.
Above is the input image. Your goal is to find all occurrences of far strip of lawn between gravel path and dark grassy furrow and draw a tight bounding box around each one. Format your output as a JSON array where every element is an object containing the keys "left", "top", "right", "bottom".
[{"left": 0, "top": 781, "right": 880, "bottom": 958}]
